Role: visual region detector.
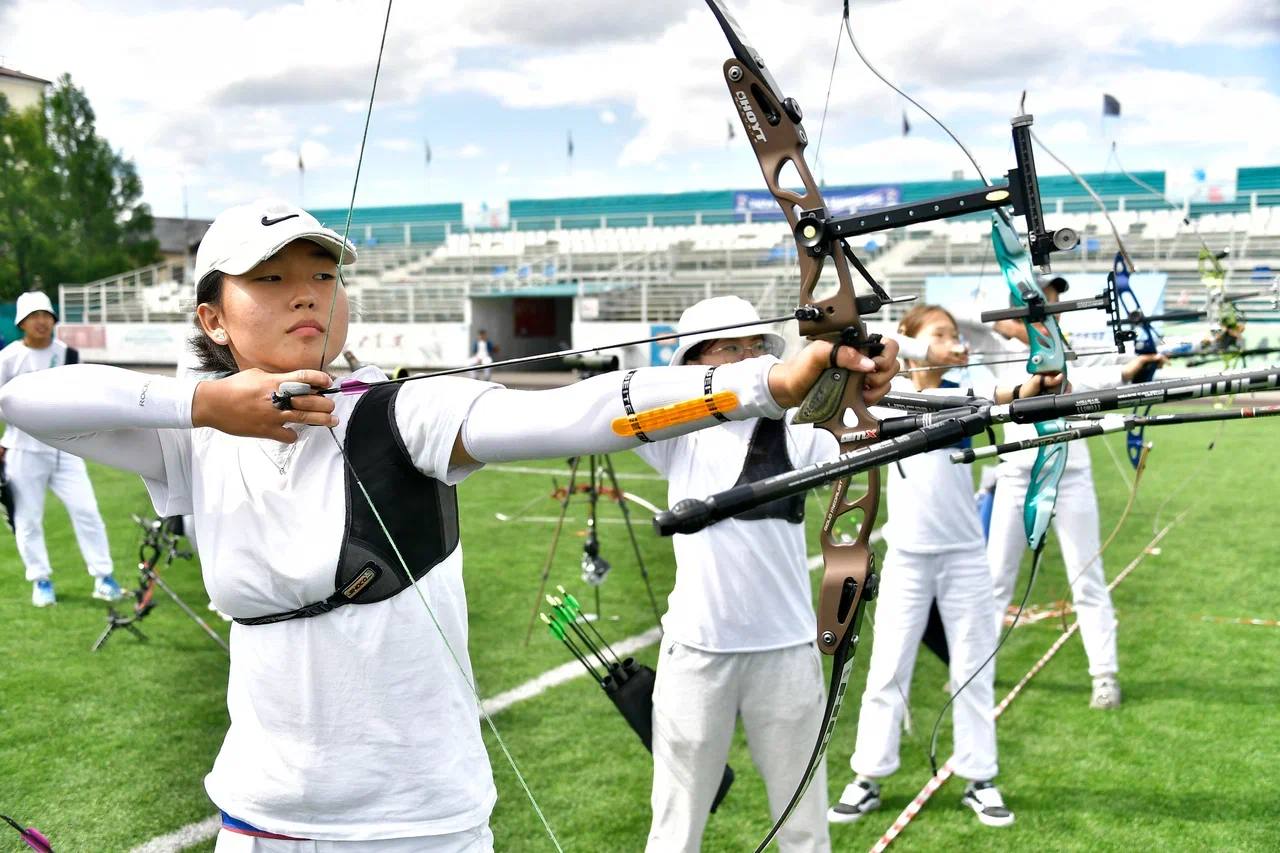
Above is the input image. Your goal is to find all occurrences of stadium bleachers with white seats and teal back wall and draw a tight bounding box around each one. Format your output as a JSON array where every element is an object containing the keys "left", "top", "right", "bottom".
[{"left": 60, "top": 167, "right": 1280, "bottom": 338}]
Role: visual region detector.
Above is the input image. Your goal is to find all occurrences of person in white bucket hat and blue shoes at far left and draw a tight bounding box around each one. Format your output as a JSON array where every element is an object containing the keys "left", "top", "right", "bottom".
[{"left": 0, "top": 291, "right": 122, "bottom": 607}]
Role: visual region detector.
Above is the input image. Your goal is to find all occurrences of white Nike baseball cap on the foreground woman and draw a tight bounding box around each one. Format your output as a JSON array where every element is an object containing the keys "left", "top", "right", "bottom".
[{"left": 196, "top": 199, "right": 356, "bottom": 286}]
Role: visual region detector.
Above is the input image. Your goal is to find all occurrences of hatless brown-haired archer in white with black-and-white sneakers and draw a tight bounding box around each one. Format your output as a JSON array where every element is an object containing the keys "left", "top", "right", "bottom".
[{"left": 827, "top": 305, "right": 1061, "bottom": 826}]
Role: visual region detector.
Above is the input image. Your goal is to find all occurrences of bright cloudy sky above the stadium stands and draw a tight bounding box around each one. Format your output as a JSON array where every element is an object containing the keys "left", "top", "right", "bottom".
[{"left": 0, "top": 0, "right": 1280, "bottom": 216}]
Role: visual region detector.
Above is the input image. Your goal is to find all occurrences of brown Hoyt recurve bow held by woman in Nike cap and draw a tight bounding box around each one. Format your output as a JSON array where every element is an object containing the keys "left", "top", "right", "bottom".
[{"left": 696, "top": 0, "right": 1076, "bottom": 850}]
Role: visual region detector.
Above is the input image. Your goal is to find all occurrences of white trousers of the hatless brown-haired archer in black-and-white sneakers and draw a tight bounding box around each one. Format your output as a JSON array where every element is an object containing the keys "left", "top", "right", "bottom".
[{"left": 849, "top": 548, "right": 998, "bottom": 780}]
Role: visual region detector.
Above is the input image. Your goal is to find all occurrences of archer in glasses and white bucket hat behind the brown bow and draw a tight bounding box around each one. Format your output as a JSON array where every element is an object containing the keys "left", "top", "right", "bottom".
[{"left": 636, "top": 296, "right": 840, "bottom": 853}]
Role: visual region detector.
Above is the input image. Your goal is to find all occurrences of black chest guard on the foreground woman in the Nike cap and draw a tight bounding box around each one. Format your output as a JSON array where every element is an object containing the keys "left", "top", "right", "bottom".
[{"left": 236, "top": 386, "right": 458, "bottom": 625}]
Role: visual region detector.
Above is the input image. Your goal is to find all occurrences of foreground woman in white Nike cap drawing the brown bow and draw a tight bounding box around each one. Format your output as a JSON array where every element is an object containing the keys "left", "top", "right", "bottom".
[{"left": 0, "top": 202, "right": 897, "bottom": 853}]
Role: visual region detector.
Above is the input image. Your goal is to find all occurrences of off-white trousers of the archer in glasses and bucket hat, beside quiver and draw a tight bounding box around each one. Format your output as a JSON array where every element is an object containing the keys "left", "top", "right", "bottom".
[{"left": 645, "top": 640, "right": 831, "bottom": 853}]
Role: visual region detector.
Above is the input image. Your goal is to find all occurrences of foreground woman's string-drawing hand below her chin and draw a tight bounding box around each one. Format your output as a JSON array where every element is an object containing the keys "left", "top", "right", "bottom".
[{"left": 191, "top": 368, "right": 338, "bottom": 444}]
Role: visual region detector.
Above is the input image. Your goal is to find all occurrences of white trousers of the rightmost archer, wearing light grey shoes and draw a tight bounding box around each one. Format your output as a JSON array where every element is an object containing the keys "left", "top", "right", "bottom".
[{"left": 987, "top": 464, "right": 1120, "bottom": 676}]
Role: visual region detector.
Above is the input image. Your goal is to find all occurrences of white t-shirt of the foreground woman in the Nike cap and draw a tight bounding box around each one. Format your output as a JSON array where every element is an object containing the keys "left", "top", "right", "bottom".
[{"left": 146, "top": 368, "right": 497, "bottom": 840}]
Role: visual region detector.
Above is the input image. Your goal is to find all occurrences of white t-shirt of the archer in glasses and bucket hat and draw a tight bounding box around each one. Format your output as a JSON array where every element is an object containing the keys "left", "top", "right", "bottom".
[{"left": 636, "top": 418, "right": 840, "bottom": 652}]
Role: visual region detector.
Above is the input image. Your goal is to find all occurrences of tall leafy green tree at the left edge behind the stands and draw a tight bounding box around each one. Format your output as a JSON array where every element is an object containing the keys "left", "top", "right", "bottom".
[{"left": 0, "top": 74, "right": 159, "bottom": 298}]
